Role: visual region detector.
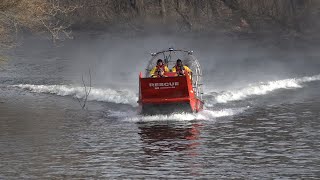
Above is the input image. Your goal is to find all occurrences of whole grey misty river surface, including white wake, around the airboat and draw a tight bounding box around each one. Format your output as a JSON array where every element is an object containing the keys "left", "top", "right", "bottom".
[{"left": 0, "top": 36, "right": 320, "bottom": 179}]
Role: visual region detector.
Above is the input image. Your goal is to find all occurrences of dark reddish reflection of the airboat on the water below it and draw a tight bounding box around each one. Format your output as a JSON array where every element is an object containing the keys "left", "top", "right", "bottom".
[{"left": 138, "top": 122, "right": 201, "bottom": 156}]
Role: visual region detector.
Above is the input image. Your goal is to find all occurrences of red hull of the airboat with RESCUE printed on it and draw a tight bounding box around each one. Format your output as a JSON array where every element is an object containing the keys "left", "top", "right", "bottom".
[{"left": 138, "top": 73, "right": 203, "bottom": 114}]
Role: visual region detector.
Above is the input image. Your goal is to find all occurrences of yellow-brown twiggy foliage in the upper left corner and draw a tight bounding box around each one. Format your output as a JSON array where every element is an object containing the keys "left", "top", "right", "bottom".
[{"left": 0, "top": 0, "right": 79, "bottom": 46}]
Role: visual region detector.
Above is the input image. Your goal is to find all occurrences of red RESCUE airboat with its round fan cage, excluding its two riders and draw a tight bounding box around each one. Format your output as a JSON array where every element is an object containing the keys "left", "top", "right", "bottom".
[{"left": 138, "top": 48, "right": 204, "bottom": 114}]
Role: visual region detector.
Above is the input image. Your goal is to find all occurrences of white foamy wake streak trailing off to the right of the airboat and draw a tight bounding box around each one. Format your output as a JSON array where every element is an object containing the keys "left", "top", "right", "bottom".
[{"left": 207, "top": 74, "right": 320, "bottom": 104}]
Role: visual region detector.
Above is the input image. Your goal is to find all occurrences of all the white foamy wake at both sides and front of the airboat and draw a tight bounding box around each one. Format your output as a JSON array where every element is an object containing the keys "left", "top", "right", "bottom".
[{"left": 10, "top": 74, "right": 320, "bottom": 121}]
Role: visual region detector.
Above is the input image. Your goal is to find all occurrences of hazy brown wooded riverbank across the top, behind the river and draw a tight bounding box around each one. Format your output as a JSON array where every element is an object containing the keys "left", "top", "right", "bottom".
[{"left": 0, "top": 0, "right": 320, "bottom": 48}]
